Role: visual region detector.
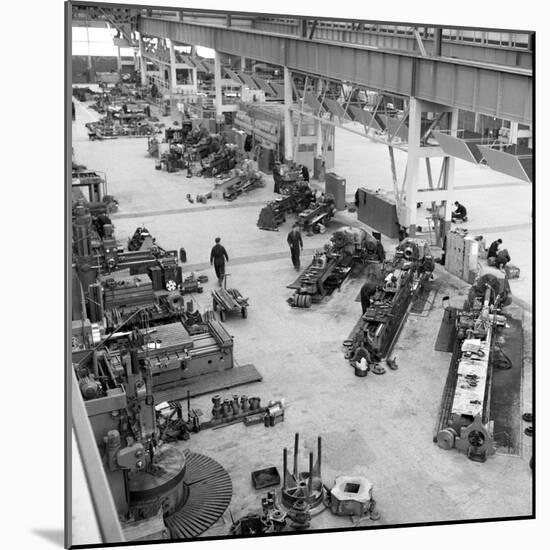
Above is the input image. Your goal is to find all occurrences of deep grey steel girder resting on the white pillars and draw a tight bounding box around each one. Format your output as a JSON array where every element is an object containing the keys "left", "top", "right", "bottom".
[{"left": 138, "top": 17, "right": 532, "bottom": 125}]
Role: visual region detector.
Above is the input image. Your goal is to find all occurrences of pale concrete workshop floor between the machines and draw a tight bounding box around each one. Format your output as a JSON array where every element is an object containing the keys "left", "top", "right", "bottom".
[{"left": 73, "top": 97, "right": 532, "bottom": 536}]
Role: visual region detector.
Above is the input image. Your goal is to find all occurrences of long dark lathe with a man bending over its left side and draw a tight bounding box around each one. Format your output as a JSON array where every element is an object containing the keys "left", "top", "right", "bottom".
[{"left": 350, "top": 238, "right": 435, "bottom": 365}]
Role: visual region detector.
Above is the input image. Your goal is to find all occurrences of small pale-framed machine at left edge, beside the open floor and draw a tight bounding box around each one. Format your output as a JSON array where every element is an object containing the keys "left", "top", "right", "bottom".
[{"left": 71, "top": 163, "right": 118, "bottom": 215}]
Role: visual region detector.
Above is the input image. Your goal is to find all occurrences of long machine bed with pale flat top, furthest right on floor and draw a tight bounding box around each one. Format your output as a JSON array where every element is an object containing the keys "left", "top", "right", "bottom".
[{"left": 434, "top": 275, "right": 506, "bottom": 462}]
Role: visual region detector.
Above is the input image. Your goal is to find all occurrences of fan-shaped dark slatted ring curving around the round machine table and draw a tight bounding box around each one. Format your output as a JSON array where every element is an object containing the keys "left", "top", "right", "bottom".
[{"left": 164, "top": 453, "right": 233, "bottom": 539}]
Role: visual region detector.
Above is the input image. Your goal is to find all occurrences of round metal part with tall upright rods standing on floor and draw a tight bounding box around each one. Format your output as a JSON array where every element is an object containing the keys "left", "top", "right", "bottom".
[{"left": 280, "top": 434, "right": 326, "bottom": 521}]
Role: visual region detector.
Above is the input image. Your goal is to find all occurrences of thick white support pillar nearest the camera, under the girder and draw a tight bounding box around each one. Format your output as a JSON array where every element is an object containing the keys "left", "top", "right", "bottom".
[{"left": 408, "top": 97, "right": 422, "bottom": 237}]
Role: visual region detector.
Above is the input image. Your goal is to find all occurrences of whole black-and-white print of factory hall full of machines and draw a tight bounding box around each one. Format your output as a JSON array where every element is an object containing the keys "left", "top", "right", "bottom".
[{"left": 67, "top": 2, "right": 535, "bottom": 545}]
